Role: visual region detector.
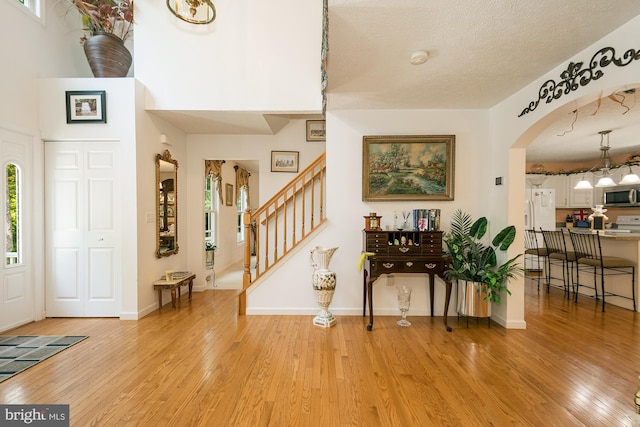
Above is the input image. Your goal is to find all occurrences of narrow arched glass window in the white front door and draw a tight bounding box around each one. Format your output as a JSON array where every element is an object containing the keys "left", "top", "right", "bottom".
[{"left": 4, "top": 163, "right": 22, "bottom": 265}]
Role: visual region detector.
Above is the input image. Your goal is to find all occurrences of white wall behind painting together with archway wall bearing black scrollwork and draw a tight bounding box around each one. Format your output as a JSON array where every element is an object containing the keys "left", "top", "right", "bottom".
[{"left": 247, "top": 17, "right": 640, "bottom": 328}]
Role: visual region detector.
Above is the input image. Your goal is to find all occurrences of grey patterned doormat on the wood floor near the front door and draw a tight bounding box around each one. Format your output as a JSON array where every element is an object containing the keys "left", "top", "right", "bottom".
[{"left": 0, "top": 335, "right": 87, "bottom": 383}]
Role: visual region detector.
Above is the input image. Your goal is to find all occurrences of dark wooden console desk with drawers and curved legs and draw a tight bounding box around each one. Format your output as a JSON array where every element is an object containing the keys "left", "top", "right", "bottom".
[{"left": 362, "top": 230, "right": 452, "bottom": 332}]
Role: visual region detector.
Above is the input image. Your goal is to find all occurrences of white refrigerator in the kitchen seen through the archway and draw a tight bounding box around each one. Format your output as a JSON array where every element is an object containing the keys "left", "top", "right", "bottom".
[{"left": 524, "top": 188, "right": 556, "bottom": 269}]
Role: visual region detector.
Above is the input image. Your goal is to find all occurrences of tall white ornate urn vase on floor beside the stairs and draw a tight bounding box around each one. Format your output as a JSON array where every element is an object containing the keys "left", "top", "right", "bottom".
[{"left": 310, "top": 246, "right": 338, "bottom": 328}]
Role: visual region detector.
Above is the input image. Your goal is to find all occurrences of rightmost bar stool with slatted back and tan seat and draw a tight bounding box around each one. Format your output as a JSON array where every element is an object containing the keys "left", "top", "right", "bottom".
[{"left": 569, "top": 230, "right": 636, "bottom": 311}]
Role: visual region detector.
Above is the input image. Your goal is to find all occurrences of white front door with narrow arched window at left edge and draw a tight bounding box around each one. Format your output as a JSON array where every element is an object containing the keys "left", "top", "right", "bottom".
[{"left": 0, "top": 128, "right": 33, "bottom": 332}]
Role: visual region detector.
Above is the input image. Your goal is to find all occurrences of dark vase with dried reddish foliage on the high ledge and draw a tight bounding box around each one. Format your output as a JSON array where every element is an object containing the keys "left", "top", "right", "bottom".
[{"left": 67, "top": 0, "right": 134, "bottom": 77}]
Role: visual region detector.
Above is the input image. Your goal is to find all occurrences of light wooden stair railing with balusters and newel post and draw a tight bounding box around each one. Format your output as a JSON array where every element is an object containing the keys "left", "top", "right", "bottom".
[{"left": 238, "top": 153, "right": 327, "bottom": 315}]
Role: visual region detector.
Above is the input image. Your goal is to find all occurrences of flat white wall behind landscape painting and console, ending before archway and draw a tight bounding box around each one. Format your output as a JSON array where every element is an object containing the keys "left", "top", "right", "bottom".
[{"left": 247, "top": 110, "right": 493, "bottom": 316}]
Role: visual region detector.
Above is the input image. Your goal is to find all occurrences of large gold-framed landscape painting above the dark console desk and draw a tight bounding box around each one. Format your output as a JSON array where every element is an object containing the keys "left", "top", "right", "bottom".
[{"left": 362, "top": 135, "right": 456, "bottom": 202}]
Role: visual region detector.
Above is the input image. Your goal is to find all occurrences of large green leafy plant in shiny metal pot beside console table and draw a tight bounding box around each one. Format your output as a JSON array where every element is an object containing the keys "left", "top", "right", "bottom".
[{"left": 443, "top": 209, "right": 524, "bottom": 317}]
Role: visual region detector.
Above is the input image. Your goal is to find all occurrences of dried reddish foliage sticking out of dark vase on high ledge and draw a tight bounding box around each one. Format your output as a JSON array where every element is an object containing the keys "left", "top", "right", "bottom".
[{"left": 67, "top": 0, "right": 134, "bottom": 43}]
